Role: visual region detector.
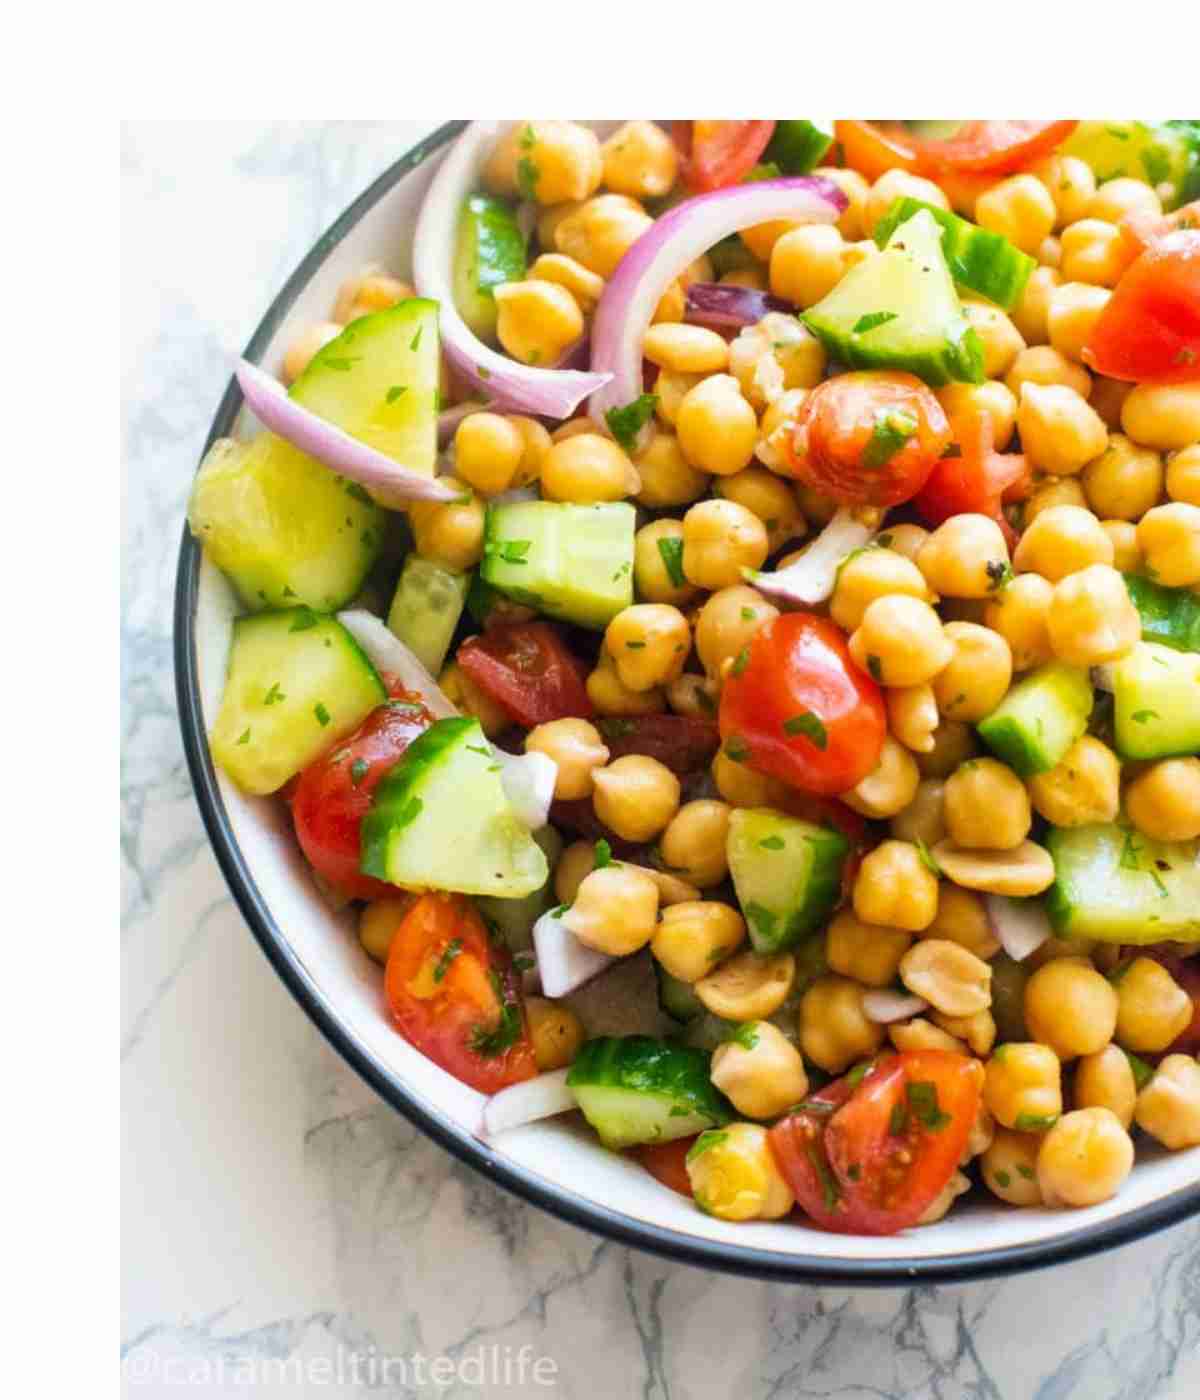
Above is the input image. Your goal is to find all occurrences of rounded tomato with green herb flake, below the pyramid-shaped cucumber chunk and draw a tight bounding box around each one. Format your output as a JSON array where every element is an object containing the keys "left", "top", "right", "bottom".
[{"left": 786, "top": 370, "right": 951, "bottom": 505}]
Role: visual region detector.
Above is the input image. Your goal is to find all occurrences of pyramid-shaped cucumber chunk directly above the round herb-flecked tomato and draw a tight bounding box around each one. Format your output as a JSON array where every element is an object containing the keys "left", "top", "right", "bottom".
[{"left": 800, "top": 209, "right": 983, "bottom": 386}]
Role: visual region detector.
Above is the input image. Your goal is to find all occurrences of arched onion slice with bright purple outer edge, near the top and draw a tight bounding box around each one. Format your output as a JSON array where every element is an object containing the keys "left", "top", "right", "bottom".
[{"left": 589, "top": 175, "right": 846, "bottom": 426}]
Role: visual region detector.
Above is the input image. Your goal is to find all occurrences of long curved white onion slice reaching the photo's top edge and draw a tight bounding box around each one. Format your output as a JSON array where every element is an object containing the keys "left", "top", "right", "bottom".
[{"left": 413, "top": 122, "right": 618, "bottom": 419}]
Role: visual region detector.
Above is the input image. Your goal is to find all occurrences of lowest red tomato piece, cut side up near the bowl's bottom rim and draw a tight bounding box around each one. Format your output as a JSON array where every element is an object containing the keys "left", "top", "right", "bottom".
[{"left": 769, "top": 1050, "right": 983, "bottom": 1235}]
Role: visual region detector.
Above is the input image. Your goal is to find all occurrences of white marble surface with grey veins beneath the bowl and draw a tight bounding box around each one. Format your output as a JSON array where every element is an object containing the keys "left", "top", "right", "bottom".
[{"left": 120, "top": 123, "right": 1200, "bottom": 1400}]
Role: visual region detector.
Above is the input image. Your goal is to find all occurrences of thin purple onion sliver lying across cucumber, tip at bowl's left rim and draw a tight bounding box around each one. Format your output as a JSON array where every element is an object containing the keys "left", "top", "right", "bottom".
[{"left": 235, "top": 360, "right": 462, "bottom": 505}]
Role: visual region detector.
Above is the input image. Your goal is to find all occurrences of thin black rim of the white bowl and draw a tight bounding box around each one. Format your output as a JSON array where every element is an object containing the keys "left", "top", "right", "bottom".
[{"left": 175, "top": 122, "right": 1200, "bottom": 1285}]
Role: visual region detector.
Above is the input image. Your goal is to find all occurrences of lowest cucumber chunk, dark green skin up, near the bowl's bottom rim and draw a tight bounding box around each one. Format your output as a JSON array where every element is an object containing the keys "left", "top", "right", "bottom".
[{"left": 567, "top": 1036, "right": 734, "bottom": 1148}]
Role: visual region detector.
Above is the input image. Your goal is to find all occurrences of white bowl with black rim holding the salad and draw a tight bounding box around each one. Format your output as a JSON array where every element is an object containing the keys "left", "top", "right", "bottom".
[{"left": 175, "top": 122, "right": 1200, "bottom": 1284}]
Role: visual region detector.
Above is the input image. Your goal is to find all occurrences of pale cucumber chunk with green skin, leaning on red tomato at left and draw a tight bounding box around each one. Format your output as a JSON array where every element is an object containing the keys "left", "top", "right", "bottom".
[{"left": 361, "top": 715, "right": 549, "bottom": 899}]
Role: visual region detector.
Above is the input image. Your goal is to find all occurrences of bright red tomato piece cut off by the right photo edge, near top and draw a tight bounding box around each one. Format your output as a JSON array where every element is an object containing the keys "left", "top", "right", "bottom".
[{"left": 1084, "top": 228, "right": 1200, "bottom": 384}]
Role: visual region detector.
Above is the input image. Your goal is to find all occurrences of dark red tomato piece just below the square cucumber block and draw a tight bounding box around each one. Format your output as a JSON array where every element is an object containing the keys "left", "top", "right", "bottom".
[{"left": 456, "top": 622, "right": 592, "bottom": 729}]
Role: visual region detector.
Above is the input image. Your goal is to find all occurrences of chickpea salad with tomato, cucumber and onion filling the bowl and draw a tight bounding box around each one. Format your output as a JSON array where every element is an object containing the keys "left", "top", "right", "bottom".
[{"left": 189, "top": 120, "right": 1200, "bottom": 1247}]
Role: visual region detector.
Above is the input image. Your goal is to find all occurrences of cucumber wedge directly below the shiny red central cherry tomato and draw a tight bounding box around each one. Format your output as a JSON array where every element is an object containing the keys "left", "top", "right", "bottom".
[{"left": 725, "top": 808, "right": 850, "bottom": 953}]
